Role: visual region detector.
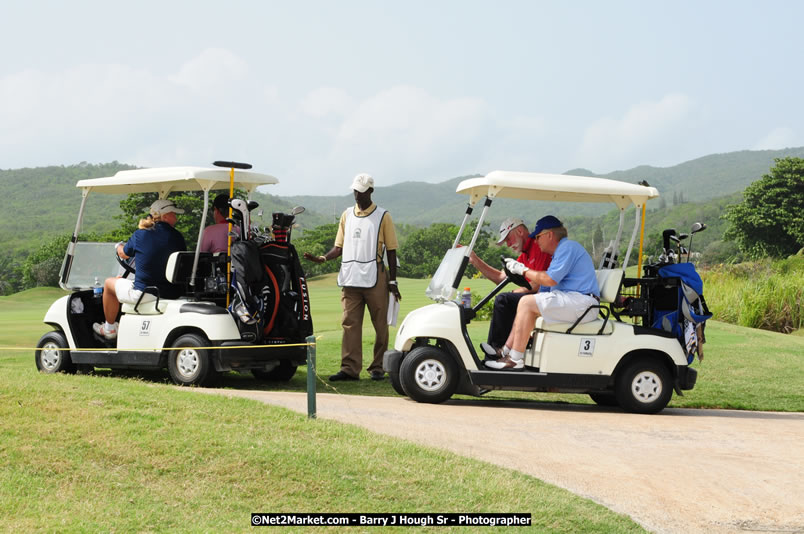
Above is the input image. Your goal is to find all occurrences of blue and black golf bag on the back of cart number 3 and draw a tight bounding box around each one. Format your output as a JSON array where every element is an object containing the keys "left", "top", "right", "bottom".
[{"left": 651, "top": 263, "right": 712, "bottom": 363}]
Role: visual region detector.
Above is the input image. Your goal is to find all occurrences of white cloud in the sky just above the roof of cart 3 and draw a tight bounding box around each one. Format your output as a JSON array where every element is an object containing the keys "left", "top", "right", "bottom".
[{"left": 575, "top": 93, "right": 693, "bottom": 172}]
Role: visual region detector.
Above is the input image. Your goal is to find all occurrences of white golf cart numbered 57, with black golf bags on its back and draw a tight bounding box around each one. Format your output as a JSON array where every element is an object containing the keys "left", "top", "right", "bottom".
[{"left": 35, "top": 162, "right": 312, "bottom": 385}]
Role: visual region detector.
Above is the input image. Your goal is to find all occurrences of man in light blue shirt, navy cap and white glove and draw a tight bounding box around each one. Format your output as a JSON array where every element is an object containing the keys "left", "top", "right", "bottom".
[{"left": 486, "top": 215, "right": 600, "bottom": 371}]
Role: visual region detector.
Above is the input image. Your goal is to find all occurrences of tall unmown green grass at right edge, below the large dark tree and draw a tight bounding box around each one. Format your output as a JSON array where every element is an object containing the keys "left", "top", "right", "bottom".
[{"left": 702, "top": 256, "right": 804, "bottom": 334}]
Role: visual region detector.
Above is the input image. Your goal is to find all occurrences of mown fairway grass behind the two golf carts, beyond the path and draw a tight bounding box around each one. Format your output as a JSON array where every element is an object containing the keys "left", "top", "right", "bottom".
[{"left": 0, "top": 275, "right": 804, "bottom": 411}]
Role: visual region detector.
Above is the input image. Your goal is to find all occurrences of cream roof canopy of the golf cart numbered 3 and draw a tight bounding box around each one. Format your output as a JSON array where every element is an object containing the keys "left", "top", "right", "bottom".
[{"left": 456, "top": 171, "right": 659, "bottom": 213}]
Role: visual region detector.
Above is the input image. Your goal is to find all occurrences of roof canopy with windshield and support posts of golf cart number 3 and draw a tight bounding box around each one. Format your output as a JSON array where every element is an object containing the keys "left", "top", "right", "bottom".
[{"left": 425, "top": 171, "right": 659, "bottom": 302}]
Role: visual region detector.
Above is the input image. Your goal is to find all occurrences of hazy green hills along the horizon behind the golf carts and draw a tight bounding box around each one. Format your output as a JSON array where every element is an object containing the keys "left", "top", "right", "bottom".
[{"left": 0, "top": 147, "right": 804, "bottom": 266}]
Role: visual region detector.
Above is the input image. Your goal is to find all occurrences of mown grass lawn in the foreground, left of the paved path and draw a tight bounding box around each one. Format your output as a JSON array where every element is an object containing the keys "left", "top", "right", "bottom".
[{"left": 0, "top": 281, "right": 643, "bottom": 533}]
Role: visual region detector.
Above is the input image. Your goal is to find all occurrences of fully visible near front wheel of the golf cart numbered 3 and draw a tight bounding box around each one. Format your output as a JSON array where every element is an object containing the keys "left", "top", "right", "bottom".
[{"left": 399, "top": 346, "right": 458, "bottom": 404}]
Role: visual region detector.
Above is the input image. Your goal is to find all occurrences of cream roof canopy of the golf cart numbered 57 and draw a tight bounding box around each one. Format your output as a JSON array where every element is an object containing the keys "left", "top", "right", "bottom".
[{"left": 76, "top": 167, "right": 279, "bottom": 198}]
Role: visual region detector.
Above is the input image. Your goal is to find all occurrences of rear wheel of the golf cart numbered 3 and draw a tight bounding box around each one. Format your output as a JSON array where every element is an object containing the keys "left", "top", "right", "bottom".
[{"left": 615, "top": 359, "right": 673, "bottom": 414}]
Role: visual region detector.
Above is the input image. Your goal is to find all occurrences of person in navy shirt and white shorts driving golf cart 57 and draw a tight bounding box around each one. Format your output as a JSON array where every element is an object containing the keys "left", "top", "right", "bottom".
[{"left": 92, "top": 199, "right": 187, "bottom": 340}]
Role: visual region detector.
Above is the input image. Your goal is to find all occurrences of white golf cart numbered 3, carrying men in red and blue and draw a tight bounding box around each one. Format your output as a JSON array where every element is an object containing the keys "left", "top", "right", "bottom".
[{"left": 383, "top": 171, "right": 697, "bottom": 413}]
